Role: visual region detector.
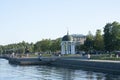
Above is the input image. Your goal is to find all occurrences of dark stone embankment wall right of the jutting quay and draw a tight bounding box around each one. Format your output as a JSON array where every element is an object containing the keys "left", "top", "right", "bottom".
[{"left": 51, "top": 58, "right": 120, "bottom": 74}]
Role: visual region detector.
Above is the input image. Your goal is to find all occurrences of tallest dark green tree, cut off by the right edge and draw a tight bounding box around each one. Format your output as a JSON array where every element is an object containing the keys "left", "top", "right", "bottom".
[{"left": 104, "top": 21, "right": 120, "bottom": 51}]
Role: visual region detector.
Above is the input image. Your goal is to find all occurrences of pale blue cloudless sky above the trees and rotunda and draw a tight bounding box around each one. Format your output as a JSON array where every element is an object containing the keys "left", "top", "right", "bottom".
[{"left": 0, "top": 0, "right": 120, "bottom": 45}]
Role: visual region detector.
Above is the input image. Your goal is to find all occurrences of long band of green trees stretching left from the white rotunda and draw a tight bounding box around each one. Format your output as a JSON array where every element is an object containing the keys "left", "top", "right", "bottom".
[{"left": 0, "top": 38, "right": 61, "bottom": 54}]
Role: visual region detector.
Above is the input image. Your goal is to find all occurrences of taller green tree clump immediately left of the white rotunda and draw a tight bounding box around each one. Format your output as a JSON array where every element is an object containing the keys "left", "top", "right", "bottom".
[{"left": 34, "top": 38, "right": 61, "bottom": 52}]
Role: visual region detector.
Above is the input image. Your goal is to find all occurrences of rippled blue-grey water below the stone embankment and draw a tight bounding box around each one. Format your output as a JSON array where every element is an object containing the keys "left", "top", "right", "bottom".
[{"left": 0, "top": 59, "right": 120, "bottom": 80}]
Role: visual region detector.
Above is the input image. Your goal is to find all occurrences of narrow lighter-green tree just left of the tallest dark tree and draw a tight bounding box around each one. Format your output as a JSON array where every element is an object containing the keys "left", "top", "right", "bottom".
[{"left": 94, "top": 30, "right": 104, "bottom": 51}]
